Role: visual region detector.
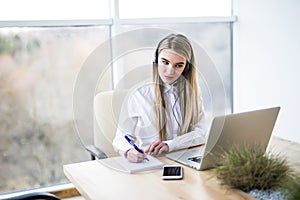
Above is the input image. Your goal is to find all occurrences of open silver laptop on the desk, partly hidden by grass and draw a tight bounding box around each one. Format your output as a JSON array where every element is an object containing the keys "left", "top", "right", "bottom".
[{"left": 166, "top": 107, "right": 280, "bottom": 170}]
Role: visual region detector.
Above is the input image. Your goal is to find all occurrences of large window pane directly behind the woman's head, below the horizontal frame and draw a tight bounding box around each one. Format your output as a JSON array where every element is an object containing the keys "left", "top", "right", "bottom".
[{"left": 112, "top": 22, "right": 232, "bottom": 120}]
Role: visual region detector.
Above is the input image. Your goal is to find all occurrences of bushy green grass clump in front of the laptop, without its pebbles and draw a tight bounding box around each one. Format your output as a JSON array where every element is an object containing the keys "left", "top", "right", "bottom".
[{"left": 213, "top": 146, "right": 292, "bottom": 192}]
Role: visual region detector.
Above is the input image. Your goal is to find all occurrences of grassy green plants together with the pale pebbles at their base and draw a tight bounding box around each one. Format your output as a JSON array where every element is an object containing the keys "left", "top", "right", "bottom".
[{"left": 213, "top": 146, "right": 300, "bottom": 200}]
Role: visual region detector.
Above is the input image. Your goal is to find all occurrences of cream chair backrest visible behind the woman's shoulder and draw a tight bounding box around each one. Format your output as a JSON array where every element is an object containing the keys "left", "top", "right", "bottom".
[{"left": 94, "top": 90, "right": 128, "bottom": 157}]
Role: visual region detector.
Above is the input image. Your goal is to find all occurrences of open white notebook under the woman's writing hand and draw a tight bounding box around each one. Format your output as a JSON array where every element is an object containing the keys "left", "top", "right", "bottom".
[{"left": 99, "top": 155, "right": 164, "bottom": 173}]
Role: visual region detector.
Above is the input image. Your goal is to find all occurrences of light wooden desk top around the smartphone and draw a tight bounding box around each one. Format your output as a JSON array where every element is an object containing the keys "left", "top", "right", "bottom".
[{"left": 64, "top": 157, "right": 254, "bottom": 200}]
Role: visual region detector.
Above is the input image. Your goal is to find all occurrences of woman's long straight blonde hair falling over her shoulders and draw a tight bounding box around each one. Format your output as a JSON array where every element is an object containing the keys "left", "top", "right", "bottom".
[{"left": 153, "top": 34, "right": 201, "bottom": 141}]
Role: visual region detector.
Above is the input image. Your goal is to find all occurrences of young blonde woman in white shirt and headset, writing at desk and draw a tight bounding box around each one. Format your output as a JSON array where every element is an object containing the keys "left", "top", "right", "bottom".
[{"left": 113, "top": 34, "right": 206, "bottom": 162}]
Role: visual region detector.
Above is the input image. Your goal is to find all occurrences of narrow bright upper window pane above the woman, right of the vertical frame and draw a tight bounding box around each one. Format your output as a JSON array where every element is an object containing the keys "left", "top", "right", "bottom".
[{"left": 119, "top": 0, "right": 231, "bottom": 19}]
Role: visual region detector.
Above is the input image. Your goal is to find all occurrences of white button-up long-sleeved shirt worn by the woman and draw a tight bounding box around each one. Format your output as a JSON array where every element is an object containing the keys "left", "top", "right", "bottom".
[{"left": 113, "top": 84, "right": 206, "bottom": 155}]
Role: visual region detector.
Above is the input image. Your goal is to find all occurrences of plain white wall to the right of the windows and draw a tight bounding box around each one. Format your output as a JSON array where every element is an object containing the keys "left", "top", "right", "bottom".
[{"left": 233, "top": 0, "right": 300, "bottom": 142}]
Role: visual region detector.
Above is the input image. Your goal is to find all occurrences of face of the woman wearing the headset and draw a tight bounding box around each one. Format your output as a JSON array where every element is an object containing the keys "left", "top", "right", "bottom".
[{"left": 158, "top": 49, "right": 186, "bottom": 84}]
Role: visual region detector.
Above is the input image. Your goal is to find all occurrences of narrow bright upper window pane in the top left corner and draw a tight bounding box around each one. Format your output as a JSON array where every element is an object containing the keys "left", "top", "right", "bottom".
[{"left": 0, "top": 0, "right": 110, "bottom": 20}]
